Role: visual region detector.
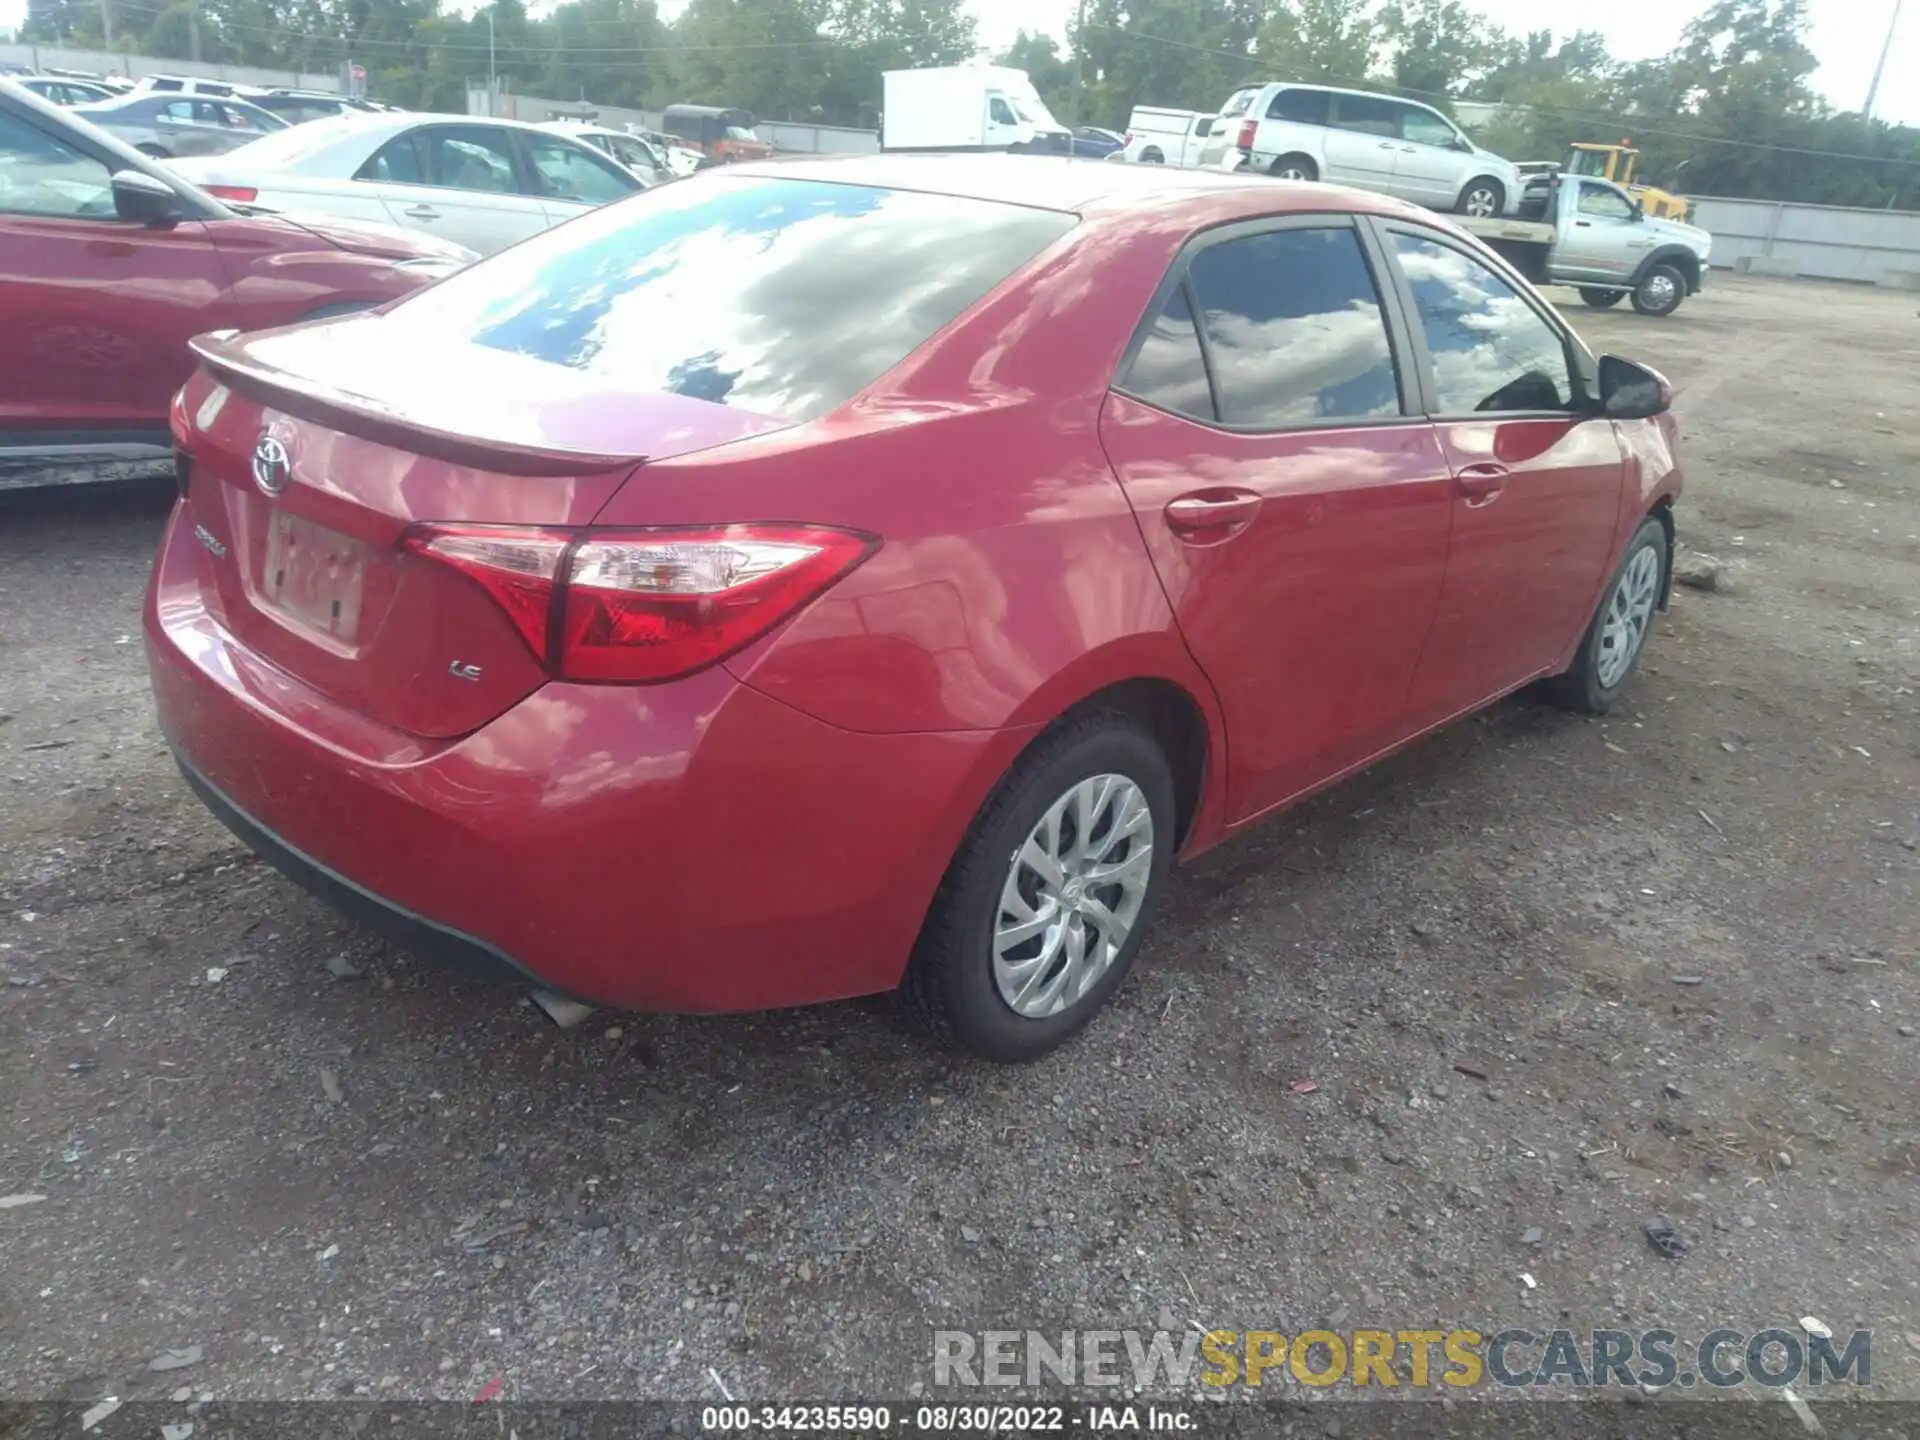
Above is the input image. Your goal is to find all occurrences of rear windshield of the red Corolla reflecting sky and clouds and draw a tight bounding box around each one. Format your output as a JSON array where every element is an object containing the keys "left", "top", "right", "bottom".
[{"left": 386, "top": 173, "right": 1075, "bottom": 420}]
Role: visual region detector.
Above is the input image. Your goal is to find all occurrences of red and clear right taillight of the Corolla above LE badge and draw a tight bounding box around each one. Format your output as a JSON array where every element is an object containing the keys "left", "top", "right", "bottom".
[{"left": 403, "top": 524, "right": 879, "bottom": 684}]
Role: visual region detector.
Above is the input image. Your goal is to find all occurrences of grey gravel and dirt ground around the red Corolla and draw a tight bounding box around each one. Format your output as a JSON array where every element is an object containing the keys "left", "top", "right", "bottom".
[{"left": 0, "top": 276, "right": 1920, "bottom": 1413}]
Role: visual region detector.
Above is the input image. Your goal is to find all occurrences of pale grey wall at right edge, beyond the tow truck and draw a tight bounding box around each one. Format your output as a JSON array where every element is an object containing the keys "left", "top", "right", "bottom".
[{"left": 1690, "top": 196, "right": 1920, "bottom": 284}]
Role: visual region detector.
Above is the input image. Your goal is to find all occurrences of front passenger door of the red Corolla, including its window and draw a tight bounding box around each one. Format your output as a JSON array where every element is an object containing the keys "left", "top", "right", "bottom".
[{"left": 1379, "top": 221, "right": 1626, "bottom": 726}]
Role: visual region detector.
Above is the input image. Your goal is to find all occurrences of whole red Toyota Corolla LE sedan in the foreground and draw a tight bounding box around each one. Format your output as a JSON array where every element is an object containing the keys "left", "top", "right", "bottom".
[{"left": 146, "top": 156, "right": 1680, "bottom": 1060}]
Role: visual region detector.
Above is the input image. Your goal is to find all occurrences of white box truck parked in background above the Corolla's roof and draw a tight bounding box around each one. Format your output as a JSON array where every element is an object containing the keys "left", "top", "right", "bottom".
[{"left": 879, "top": 65, "right": 1071, "bottom": 156}]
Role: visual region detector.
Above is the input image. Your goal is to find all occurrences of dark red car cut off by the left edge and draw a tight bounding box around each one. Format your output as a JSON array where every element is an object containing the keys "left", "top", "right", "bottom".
[{"left": 0, "top": 81, "right": 472, "bottom": 488}]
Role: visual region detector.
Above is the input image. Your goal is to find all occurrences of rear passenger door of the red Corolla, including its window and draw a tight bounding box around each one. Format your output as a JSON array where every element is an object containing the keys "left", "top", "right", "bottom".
[{"left": 1100, "top": 215, "right": 1452, "bottom": 820}]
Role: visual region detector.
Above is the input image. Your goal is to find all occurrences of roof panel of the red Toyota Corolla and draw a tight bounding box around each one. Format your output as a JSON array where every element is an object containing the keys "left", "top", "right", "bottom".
[{"left": 728, "top": 154, "right": 1436, "bottom": 225}]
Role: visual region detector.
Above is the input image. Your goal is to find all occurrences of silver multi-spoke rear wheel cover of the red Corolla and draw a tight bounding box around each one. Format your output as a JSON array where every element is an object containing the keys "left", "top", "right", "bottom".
[{"left": 993, "top": 774, "right": 1154, "bottom": 1020}]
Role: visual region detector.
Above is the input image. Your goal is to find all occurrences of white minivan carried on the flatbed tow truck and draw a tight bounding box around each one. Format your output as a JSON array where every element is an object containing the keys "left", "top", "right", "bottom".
[{"left": 1200, "top": 84, "right": 1524, "bottom": 215}]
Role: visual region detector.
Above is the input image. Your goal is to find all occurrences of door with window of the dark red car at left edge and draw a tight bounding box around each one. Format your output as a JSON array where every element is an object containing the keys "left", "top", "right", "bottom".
[{"left": 0, "top": 111, "right": 240, "bottom": 444}]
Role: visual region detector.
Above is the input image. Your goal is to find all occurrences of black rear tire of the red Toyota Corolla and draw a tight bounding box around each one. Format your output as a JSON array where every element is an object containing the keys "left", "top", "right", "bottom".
[{"left": 899, "top": 710, "right": 1173, "bottom": 1064}]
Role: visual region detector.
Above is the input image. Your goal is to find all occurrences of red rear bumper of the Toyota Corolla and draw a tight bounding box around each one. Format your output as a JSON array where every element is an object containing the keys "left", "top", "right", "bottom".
[{"left": 146, "top": 511, "right": 1031, "bottom": 1012}]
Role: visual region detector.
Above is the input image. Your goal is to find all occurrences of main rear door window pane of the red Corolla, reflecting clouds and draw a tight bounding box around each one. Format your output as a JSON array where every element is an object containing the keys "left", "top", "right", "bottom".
[{"left": 1188, "top": 227, "right": 1400, "bottom": 428}]
